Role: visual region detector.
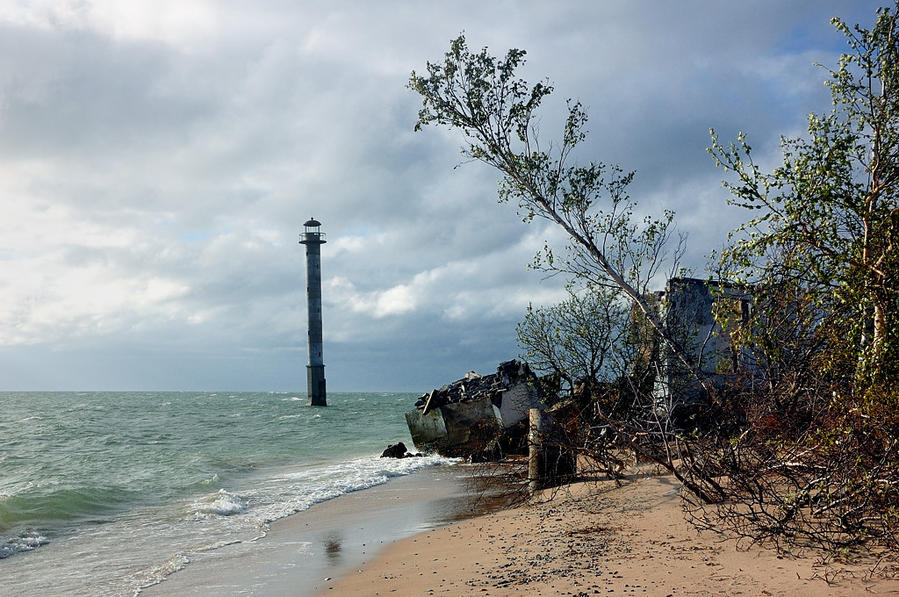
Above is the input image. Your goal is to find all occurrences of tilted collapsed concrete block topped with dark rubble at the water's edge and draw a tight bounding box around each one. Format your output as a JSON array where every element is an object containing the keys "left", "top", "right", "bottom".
[{"left": 406, "top": 360, "right": 555, "bottom": 457}]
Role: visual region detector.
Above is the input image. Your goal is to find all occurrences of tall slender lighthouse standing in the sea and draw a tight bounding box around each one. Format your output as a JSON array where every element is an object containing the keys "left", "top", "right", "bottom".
[{"left": 300, "top": 218, "right": 328, "bottom": 406}]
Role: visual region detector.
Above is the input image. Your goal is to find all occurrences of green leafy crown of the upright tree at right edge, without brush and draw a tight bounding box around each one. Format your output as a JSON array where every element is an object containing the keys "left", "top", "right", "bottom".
[{"left": 711, "top": 3, "right": 899, "bottom": 383}]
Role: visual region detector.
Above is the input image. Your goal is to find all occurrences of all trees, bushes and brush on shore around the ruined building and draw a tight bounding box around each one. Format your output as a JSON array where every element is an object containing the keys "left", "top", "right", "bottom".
[{"left": 409, "top": 2, "right": 899, "bottom": 552}]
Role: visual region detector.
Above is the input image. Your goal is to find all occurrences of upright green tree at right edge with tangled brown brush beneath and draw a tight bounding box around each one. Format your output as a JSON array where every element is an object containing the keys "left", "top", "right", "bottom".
[{"left": 692, "top": 3, "right": 899, "bottom": 551}]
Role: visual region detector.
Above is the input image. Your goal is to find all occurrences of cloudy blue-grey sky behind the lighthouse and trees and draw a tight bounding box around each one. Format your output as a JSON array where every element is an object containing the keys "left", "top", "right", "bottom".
[{"left": 0, "top": 0, "right": 878, "bottom": 392}]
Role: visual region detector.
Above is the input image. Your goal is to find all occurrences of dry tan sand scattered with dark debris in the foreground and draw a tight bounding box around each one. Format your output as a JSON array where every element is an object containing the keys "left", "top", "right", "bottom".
[{"left": 320, "top": 476, "right": 899, "bottom": 596}]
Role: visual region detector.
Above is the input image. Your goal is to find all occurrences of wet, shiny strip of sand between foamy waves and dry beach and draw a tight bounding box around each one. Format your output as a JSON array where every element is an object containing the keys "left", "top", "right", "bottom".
[{"left": 140, "top": 464, "right": 492, "bottom": 597}]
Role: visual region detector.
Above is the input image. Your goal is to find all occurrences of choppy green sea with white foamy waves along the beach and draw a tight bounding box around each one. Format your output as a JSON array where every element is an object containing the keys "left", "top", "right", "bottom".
[{"left": 0, "top": 392, "right": 448, "bottom": 596}]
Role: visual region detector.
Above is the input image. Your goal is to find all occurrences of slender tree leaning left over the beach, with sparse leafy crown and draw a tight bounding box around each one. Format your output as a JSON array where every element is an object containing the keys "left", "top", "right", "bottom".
[{"left": 409, "top": 35, "right": 704, "bottom": 382}]
